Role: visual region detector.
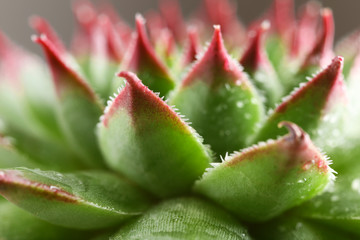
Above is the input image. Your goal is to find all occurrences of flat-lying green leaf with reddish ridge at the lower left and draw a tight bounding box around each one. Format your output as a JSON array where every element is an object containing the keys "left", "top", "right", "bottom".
[{"left": 0, "top": 168, "right": 151, "bottom": 229}]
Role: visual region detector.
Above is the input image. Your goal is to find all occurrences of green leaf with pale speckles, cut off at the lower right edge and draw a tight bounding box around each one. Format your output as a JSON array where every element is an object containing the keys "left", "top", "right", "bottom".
[{"left": 295, "top": 167, "right": 360, "bottom": 236}]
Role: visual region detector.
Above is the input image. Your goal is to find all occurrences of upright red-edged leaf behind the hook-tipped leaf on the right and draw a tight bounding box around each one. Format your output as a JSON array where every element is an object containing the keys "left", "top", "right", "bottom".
[{"left": 254, "top": 57, "right": 346, "bottom": 150}]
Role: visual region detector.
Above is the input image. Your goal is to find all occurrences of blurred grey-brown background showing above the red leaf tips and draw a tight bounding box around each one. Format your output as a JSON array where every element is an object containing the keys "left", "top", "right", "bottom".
[{"left": 0, "top": 0, "right": 360, "bottom": 53}]
